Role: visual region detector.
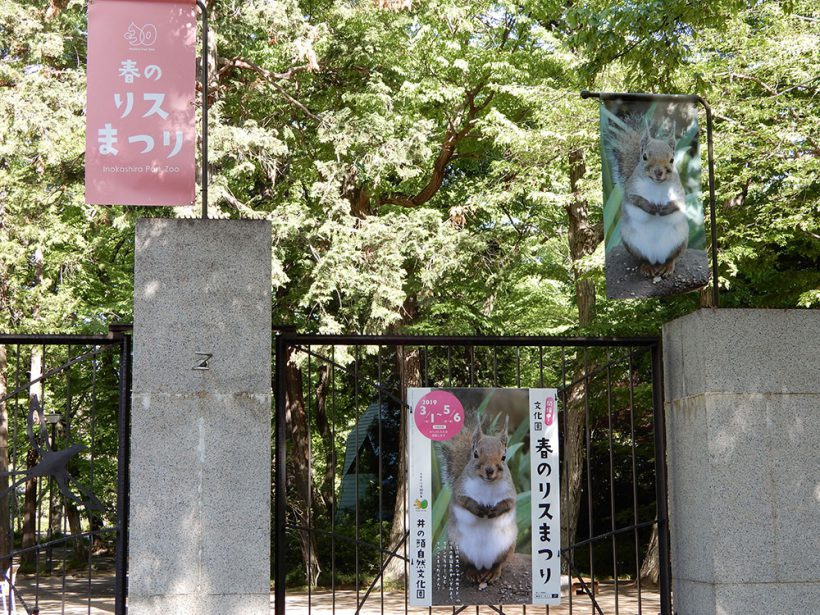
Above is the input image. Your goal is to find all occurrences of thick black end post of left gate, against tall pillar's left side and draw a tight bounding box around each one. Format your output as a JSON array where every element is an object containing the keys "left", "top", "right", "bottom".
[{"left": 114, "top": 335, "right": 131, "bottom": 615}]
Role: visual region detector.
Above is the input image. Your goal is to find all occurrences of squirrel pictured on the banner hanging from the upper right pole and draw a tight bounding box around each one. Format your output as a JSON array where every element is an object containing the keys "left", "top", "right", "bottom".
[{"left": 607, "top": 116, "right": 689, "bottom": 278}]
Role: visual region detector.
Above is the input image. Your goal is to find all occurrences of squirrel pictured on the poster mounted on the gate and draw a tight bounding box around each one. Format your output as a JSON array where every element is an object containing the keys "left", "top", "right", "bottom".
[{"left": 441, "top": 416, "right": 518, "bottom": 583}]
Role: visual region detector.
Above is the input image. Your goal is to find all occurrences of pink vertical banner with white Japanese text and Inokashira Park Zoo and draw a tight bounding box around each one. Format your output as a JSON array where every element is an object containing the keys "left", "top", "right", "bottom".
[{"left": 85, "top": 0, "right": 196, "bottom": 205}]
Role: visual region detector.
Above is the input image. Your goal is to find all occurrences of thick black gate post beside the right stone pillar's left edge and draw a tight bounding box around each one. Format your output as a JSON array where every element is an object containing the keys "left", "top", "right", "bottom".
[{"left": 652, "top": 344, "right": 672, "bottom": 615}]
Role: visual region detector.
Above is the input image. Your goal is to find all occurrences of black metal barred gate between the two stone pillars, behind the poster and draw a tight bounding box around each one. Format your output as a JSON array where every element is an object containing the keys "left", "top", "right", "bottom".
[{"left": 273, "top": 329, "right": 672, "bottom": 615}]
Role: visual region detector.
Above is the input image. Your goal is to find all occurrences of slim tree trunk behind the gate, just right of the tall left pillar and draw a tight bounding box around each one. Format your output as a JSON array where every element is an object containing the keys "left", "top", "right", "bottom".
[{"left": 279, "top": 357, "right": 321, "bottom": 585}]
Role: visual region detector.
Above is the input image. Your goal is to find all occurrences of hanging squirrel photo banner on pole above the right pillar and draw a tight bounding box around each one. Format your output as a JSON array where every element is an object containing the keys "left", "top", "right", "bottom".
[{"left": 600, "top": 98, "right": 709, "bottom": 299}]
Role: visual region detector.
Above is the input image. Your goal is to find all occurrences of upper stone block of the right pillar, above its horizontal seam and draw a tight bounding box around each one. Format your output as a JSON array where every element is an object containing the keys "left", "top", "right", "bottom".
[{"left": 664, "top": 309, "right": 820, "bottom": 399}]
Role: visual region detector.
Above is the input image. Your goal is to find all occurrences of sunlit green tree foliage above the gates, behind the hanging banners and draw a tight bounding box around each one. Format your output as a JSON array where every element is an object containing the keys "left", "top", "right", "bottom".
[{"left": 0, "top": 0, "right": 820, "bottom": 334}]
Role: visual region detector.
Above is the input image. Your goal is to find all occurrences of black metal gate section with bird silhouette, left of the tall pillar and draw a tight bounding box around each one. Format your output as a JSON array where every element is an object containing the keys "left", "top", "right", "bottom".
[{"left": 0, "top": 327, "right": 131, "bottom": 615}]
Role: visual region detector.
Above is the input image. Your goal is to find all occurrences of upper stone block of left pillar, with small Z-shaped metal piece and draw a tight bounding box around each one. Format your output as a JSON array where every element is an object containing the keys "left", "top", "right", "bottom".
[{"left": 133, "top": 218, "right": 271, "bottom": 393}]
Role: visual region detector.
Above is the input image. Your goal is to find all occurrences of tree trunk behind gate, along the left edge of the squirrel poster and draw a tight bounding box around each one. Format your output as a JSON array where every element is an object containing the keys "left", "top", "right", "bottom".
[{"left": 384, "top": 346, "right": 421, "bottom": 583}]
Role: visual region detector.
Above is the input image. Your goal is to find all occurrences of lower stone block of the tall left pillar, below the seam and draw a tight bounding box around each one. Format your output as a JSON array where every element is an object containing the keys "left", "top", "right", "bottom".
[{"left": 129, "top": 393, "right": 271, "bottom": 596}]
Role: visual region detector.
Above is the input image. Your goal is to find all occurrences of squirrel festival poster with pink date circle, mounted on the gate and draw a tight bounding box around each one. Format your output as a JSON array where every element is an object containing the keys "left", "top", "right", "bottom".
[{"left": 407, "top": 388, "right": 561, "bottom": 606}]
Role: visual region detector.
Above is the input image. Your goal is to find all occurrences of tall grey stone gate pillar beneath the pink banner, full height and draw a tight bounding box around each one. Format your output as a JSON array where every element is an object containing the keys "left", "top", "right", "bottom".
[{"left": 128, "top": 219, "right": 271, "bottom": 615}]
